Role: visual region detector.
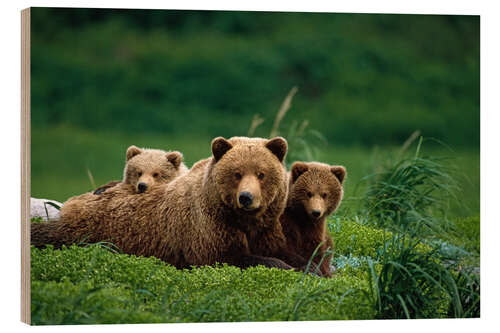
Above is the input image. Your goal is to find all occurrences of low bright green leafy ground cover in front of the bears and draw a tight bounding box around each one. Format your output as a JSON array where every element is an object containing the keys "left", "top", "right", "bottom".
[{"left": 31, "top": 245, "right": 374, "bottom": 324}]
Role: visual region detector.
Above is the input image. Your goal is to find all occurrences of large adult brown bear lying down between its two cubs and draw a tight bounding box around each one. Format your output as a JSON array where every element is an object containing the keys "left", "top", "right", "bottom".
[{"left": 31, "top": 137, "right": 307, "bottom": 269}]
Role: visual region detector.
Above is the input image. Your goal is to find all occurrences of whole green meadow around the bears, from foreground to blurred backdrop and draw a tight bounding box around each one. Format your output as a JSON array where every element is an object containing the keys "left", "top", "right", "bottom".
[{"left": 31, "top": 8, "right": 480, "bottom": 325}]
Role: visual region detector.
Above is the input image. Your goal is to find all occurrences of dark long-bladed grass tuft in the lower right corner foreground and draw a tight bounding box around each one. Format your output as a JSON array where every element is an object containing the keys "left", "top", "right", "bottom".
[{"left": 368, "top": 234, "right": 466, "bottom": 319}]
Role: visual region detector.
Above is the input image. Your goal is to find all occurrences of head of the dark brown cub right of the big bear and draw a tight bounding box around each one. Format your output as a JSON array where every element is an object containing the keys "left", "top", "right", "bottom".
[{"left": 287, "top": 162, "right": 346, "bottom": 221}]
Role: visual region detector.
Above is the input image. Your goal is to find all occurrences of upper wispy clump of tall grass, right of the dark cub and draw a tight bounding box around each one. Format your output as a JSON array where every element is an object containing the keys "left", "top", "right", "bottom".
[{"left": 365, "top": 137, "right": 457, "bottom": 233}]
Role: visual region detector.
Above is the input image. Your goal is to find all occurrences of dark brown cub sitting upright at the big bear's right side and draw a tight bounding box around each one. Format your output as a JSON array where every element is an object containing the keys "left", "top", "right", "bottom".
[{"left": 280, "top": 162, "right": 346, "bottom": 277}]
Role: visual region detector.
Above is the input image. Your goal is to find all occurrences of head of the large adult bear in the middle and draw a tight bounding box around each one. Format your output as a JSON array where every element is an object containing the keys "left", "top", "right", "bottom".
[{"left": 212, "top": 137, "right": 287, "bottom": 215}]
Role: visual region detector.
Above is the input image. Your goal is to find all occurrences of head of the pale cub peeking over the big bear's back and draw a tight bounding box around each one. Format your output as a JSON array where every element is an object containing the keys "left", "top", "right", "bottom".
[{"left": 123, "top": 146, "right": 186, "bottom": 193}]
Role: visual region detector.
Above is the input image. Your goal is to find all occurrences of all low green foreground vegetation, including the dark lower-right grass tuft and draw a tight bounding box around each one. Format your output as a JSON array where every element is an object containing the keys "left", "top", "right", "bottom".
[{"left": 31, "top": 218, "right": 479, "bottom": 325}]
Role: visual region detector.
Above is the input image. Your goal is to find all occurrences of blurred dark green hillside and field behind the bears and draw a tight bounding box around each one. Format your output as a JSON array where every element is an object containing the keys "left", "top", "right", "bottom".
[{"left": 31, "top": 8, "right": 480, "bottom": 216}]
